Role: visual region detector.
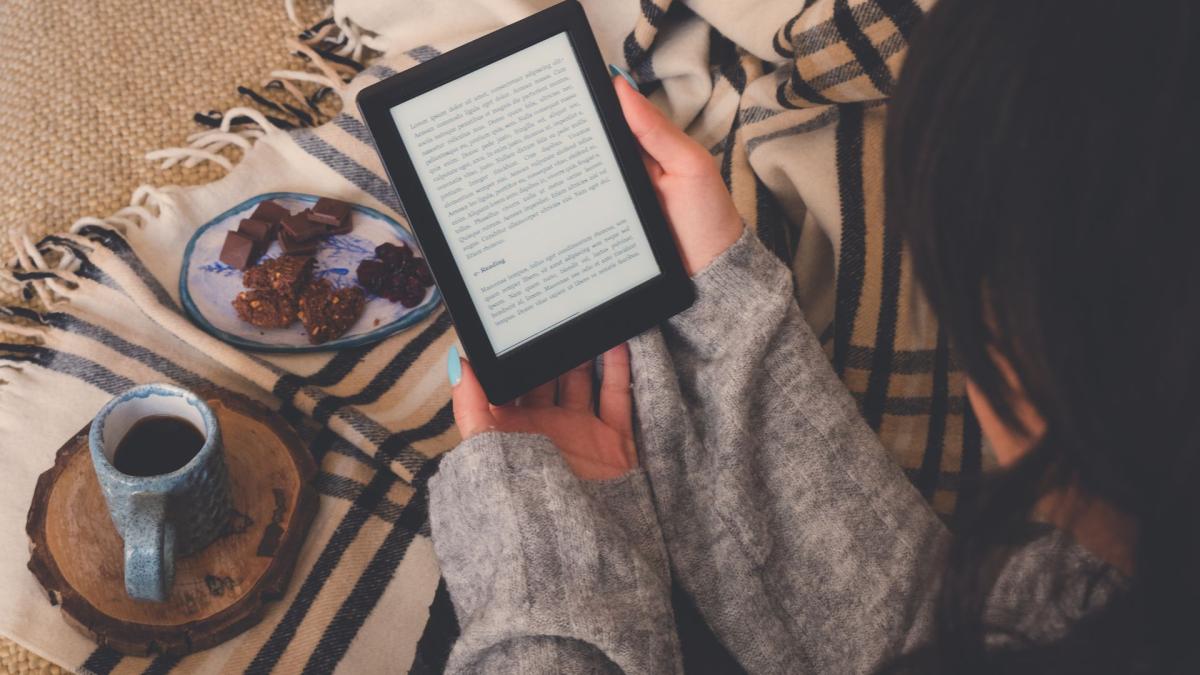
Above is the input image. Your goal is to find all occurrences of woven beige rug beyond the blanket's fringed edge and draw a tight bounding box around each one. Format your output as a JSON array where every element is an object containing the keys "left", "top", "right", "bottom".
[{"left": 0, "top": 0, "right": 325, "bottom": 673}]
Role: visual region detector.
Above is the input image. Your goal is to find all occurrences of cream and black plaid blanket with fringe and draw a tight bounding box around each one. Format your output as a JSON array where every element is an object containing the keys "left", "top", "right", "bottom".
[{"left": 0, "top": 0, "right": 985, "bottom": 673}]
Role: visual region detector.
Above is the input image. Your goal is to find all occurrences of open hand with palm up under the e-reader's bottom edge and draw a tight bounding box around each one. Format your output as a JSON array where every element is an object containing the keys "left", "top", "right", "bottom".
[{"left": 449, "top": 345, "right": 637, "bottom": 480}]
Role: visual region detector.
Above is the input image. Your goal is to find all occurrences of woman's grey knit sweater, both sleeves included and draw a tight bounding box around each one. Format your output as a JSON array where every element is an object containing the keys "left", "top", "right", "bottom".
[{"left": 430, "top": 232, "right": 1120, "bottom": 673}]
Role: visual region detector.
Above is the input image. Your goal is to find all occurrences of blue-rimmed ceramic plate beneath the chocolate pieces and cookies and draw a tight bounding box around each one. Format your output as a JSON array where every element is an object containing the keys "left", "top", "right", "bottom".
[{"left": 179, "top": 192, "right": 442, "bottom": 352}]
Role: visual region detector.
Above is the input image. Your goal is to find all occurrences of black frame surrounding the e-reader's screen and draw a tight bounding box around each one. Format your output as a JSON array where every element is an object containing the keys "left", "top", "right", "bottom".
[{"left": 358, "top": 0, "right": 694, "bottom": 404}]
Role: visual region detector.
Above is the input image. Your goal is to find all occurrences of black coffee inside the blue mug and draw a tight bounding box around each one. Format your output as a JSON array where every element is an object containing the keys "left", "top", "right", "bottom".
[{"left": 113, "top": 414, "right": 204, "bottom": 476}]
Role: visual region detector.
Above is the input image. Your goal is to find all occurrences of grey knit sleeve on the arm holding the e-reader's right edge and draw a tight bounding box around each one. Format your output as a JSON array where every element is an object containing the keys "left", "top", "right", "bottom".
[{"left": 631, "top": 232, "right": 947, "bottom": 673}]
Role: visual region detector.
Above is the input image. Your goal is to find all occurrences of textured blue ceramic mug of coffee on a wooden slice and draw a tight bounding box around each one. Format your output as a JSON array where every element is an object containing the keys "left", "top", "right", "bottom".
[{"left": 88, "top": 384, "right": 232, "bottom": 602}]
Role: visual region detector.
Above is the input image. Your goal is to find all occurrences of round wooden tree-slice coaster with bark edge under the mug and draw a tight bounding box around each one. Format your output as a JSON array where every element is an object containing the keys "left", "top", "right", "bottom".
[{"left": 25, "top": 392, "right": 317, "bottom": 655}]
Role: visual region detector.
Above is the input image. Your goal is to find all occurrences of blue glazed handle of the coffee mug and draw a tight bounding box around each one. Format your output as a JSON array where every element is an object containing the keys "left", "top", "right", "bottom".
[{"left": 125, "top": 492, "right": 175, "bottom": 602}]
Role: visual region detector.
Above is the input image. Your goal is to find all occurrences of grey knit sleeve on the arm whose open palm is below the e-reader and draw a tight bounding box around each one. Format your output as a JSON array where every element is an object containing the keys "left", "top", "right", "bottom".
[{"left": 430, "top": 432, "right": 682, "bottom": 674}]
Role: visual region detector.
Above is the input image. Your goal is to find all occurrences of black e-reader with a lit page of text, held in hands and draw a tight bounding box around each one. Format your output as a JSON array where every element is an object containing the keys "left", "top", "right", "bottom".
[{"left": 358, "top": 0, "right": 694, "bottom": 404}]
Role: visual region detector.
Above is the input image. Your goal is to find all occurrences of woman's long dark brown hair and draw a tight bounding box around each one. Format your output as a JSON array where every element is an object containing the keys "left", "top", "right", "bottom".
[{"left": 886, "top": 0, "right": 1200, "bottom": 673}]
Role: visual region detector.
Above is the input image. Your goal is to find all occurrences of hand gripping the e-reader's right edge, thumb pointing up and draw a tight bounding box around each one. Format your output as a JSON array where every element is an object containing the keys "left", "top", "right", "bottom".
[{"left": 613, "top": 77, "right": 743, "bottom": 276}]
